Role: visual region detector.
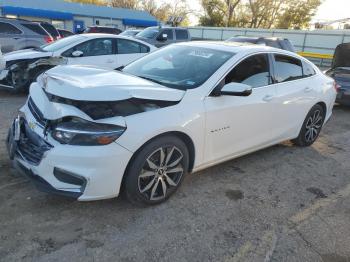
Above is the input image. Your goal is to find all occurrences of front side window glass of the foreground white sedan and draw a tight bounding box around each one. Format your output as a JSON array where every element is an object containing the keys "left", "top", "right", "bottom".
[{"left": 225, "top": 54, "right": 271, "bottom": 88}]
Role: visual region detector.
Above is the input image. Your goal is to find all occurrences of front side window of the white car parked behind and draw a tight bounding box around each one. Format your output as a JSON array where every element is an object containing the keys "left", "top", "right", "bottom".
[{"left": 62, "top": 38, "right": 113, "bottom": 57}]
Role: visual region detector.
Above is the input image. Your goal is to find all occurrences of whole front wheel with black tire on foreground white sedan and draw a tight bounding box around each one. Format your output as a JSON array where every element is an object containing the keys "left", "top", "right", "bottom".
[{"left": 124, "top": 136, "right": 189, "bottom": 205}]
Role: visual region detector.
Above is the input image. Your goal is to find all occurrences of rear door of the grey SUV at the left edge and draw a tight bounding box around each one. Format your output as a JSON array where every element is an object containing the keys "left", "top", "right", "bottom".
[{"left": 0, "top": 22, "right": 24, "bottom": 53}]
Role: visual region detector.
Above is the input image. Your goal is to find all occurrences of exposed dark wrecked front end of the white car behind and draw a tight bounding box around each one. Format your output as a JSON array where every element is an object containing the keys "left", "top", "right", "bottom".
[{"left": 0, "top": 57, "right": 67, "bottom": 91}]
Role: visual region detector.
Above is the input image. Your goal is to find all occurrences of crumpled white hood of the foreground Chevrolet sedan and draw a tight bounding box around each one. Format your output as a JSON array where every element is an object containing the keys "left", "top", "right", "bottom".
[{"left": 38, "top": 66, "right": 185, "bottom": 101}]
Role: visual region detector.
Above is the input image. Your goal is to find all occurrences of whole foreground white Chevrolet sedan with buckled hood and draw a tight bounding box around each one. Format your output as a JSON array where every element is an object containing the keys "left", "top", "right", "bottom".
[{"left": 7, "top": 42, "right": 336, "bottom": 204}]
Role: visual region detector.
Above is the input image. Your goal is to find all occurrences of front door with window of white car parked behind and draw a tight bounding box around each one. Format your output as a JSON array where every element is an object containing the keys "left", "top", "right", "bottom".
[{"left": 62, "top": 38, "right": 117, "bottom": 69}]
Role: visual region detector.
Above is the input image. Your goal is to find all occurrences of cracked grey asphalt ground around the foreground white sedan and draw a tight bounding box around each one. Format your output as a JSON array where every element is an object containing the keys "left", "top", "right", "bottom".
[{"left": 0, "top": 92, "right": 350, "bottom": 262}]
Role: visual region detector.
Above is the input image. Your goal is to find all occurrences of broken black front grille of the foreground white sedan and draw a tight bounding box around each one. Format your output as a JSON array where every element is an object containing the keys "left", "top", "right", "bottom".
[{"left": 17, "top": 121, "right": 53, "bottom": 166}]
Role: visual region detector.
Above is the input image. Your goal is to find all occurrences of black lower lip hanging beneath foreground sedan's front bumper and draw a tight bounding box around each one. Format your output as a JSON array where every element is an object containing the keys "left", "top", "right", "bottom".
[{"left": 16, "top": 161, "right": 83, "bottom": 199}]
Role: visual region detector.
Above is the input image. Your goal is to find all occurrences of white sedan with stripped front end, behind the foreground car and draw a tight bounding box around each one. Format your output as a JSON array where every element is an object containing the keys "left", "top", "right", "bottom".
[{"left": 0, "top": 34, "right": 156, "bottom": 92}]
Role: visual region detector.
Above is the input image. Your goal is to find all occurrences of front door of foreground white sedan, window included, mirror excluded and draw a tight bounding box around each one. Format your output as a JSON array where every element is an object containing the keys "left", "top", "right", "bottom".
[{"left": 204, "top": 54, "right": 276, "bottom": 162}]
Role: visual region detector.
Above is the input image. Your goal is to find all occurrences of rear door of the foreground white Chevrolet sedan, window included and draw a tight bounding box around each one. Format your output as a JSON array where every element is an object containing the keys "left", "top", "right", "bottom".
[{"left": 271, "top": 54, "right": 316, "bottom": 139}]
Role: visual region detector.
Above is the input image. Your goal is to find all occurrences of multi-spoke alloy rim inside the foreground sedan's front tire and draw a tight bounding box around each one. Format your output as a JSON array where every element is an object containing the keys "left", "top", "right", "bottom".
[{"left": 138, "top": 146, "right": 184, "bottom": 201}]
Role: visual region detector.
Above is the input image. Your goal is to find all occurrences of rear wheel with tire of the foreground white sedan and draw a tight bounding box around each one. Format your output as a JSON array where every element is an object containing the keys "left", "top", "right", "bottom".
[{"left": 292, "top": 104, "right": 326, "bottom": 147}]
